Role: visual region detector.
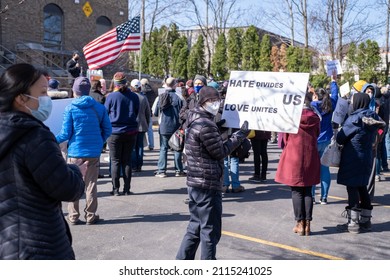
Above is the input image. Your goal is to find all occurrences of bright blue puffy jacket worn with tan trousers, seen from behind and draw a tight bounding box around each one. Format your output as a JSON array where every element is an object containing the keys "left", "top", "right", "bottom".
[{"left": 56, "top": 95, "right": 111, "bottom": 158}]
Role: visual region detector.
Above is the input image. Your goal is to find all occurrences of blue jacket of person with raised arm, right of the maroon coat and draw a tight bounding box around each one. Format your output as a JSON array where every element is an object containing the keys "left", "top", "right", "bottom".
[{"left": 311, "top": 81, "right": 339, "bottom": 143}]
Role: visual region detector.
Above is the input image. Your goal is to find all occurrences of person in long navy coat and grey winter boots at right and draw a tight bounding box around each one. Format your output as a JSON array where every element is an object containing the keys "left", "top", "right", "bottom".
[{"left": 336, "top": 92, "right": 385, "bottom": 233}]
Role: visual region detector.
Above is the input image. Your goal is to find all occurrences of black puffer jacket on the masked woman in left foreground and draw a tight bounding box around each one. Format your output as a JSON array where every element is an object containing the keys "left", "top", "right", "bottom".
[{"left": 0, "top": 112, "right": 85, "bottom": 259}]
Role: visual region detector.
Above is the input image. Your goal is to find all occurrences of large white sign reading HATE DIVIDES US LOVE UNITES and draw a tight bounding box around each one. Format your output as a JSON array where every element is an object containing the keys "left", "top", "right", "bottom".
[{"left": 222, "top": 71, "right": 309, "bottom": 133}]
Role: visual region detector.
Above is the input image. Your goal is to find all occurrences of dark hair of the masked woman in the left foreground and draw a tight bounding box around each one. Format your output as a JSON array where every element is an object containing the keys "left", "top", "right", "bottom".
[{"left": 0, "top": 63, "right": 43, "bottom": 112}]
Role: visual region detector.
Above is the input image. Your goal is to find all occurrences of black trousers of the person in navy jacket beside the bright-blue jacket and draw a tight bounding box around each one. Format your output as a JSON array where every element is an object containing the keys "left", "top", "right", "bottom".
[{"left": 107, "top": 133, "right": 137, "bottom": 192}]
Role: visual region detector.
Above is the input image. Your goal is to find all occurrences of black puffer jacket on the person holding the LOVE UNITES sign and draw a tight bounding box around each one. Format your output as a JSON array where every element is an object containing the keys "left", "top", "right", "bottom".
[{"left": 185, "top": 107, "right": 241, "bottom": 190}]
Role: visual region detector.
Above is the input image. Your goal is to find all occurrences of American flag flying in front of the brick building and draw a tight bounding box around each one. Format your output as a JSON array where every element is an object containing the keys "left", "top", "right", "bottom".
[{"left": 83, "top": 16, "right": 141, "bottom": 70}]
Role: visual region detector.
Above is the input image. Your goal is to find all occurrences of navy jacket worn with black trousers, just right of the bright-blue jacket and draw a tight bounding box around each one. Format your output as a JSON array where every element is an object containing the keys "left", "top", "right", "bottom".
[{"left": 104, "top": 89, "right": 140, "bottom": 134}]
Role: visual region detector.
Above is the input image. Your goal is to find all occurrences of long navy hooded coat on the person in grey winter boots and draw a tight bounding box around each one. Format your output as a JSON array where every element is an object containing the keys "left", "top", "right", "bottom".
[{"left": 336, "top": 109, "right": 379, "bottom": 187}]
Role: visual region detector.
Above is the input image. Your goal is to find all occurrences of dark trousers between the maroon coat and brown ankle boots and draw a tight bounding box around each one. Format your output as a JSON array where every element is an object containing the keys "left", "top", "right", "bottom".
[{"left": 291, "top": 186, "right": 313, "bottom": 221}]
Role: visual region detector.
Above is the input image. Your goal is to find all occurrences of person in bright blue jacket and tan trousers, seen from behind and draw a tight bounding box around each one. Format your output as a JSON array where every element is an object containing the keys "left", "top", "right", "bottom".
[{"left": 56, "top": 77, "right": 112, "bottom": 225}]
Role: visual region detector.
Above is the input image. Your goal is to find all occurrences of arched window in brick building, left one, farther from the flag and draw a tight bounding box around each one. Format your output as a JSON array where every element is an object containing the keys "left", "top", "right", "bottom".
[{"left": 43, "top": 4, "right": 64, "bottom": 45}]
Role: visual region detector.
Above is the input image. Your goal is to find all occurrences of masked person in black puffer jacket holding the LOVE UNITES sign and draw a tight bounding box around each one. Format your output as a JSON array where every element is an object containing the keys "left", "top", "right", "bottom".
[{"left": 176, "top": 86, "right": 249, "bottom": 260}]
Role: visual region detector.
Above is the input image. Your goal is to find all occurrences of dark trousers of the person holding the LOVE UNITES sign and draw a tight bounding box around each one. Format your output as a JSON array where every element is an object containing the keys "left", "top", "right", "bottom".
[{"left": 176, "top": 187, "right": 222, "bottom": 260}]
